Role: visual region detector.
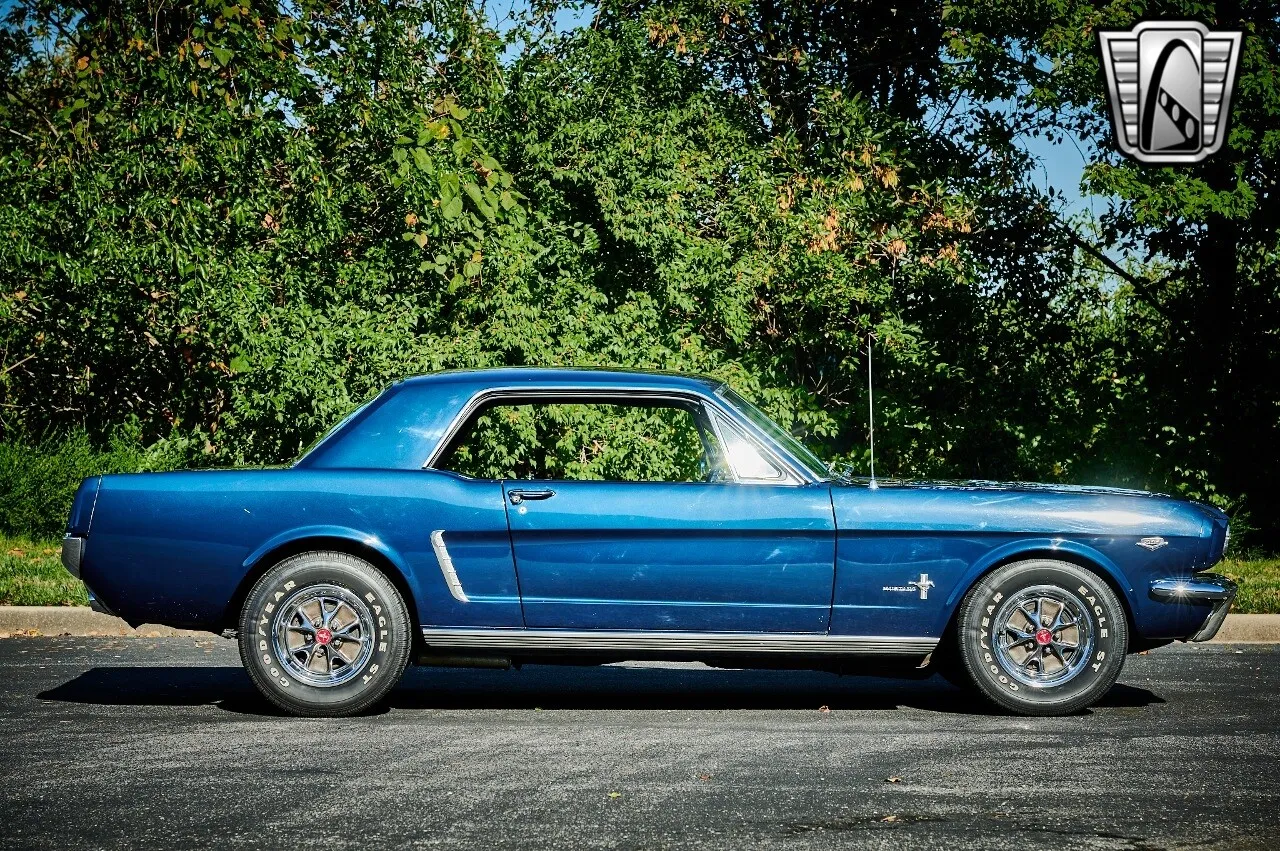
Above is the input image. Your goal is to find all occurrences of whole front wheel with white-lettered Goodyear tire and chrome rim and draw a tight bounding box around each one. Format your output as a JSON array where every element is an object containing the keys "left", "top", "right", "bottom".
[{"left": 956, "top": 559, "right": 1128, "bottom": 715}]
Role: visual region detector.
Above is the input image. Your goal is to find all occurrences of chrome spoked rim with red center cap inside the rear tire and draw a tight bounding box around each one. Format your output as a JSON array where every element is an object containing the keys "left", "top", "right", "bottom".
[{"left": 271, "top": 585, "right": 375, "bottom": 687}]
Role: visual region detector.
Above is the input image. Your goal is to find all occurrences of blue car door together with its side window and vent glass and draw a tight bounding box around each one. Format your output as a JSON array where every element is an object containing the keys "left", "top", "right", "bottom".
[{"left": 437, "top": 397, "right": 835, "bottom": 632}]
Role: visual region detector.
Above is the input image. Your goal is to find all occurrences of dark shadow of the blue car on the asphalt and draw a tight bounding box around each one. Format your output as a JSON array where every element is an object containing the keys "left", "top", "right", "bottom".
[{"left": 37, "top": 665, "right": 1165, "bottom": 715}]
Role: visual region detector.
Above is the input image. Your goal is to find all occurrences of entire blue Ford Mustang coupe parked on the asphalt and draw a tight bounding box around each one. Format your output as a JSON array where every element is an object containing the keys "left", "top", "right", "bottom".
[{"left": 63, "top": 369, "right": 1235, "bottom": 715}]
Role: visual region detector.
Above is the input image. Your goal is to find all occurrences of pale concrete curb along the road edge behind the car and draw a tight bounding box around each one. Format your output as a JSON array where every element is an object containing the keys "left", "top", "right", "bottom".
[{"left": 0, "top": 605, "right": 1280, "bottom": 644}]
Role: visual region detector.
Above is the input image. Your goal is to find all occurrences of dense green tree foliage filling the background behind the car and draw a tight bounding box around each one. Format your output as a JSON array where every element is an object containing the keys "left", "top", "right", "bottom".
[{"left": 0, "top": 0, "right": 1280, "bottom": 545}]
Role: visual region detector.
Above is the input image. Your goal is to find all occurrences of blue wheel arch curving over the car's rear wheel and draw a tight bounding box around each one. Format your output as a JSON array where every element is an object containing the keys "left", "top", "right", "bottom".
[{"left": 221, "top": 527, "right": 422, "bottom": 645}]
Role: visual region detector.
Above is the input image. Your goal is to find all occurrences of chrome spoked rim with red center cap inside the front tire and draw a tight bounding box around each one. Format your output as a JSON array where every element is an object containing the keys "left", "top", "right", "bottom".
[{"left": 991, "top": 585, "right": 1094, "bottom": 688}]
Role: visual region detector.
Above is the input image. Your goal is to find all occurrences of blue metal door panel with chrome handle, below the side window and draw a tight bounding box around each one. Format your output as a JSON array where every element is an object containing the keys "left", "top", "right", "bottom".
[{"left": 503, "top": 481, "right": 835, "bottom": 632}]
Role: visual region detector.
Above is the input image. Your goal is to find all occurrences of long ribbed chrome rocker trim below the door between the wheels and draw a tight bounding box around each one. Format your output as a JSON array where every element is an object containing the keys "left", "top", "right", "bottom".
[{"left": 422, "top": 627, "right": 938, "bottom": 656}]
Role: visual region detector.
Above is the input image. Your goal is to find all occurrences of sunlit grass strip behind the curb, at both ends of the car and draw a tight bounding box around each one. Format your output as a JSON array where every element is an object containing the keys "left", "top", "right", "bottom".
[{"left": 0, "top": 535, "right": 1280, "bottom": 614}]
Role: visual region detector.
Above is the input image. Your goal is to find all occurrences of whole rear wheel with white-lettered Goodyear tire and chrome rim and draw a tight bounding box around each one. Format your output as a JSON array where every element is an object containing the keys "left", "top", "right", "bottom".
[{"left": 239, "top": 552, "right": 412, "bottom": 717}]
